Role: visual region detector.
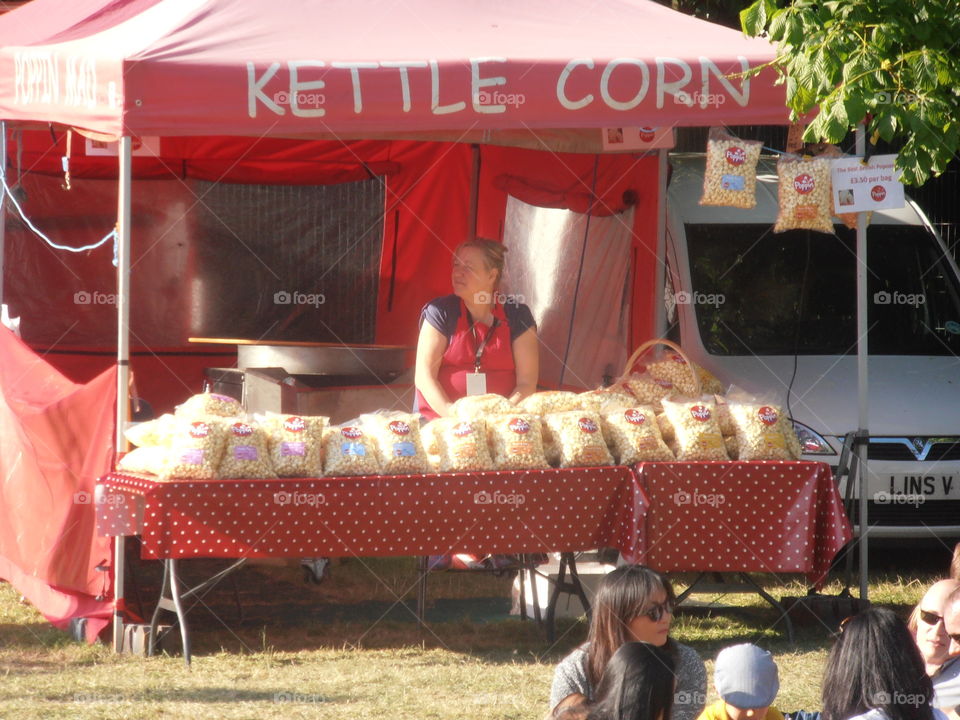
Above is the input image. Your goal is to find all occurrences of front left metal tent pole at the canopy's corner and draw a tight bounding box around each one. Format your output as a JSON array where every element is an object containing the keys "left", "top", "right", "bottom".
[{"left": 113, "top": 136, "right": 133, "bottom": 652}]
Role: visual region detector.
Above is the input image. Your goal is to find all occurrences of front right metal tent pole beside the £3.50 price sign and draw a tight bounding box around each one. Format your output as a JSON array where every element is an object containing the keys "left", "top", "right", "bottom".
[{"left": 848, "top": 123, "right": 870, "bottom": 600}]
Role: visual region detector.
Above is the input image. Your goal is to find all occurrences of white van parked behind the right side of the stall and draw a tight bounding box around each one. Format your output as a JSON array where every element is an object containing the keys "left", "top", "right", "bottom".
[{"left": 665, "top": 155, "right": 960, "bottom": 538}]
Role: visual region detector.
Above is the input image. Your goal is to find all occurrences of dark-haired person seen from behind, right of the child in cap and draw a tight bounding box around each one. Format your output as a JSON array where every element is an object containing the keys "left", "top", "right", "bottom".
[{"left": 821, "top": 607, "right": 946, "bottom": 720}]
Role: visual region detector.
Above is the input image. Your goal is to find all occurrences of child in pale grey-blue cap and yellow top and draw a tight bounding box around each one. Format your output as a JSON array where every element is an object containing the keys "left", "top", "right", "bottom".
[{"left": 698, "top": 644, "right": 783, "bottom": 720}]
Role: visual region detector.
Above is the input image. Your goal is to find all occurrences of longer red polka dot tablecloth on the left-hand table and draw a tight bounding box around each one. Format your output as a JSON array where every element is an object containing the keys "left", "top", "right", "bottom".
[{"left": 98, "top": 467, "right": 646, "bottom": 558}]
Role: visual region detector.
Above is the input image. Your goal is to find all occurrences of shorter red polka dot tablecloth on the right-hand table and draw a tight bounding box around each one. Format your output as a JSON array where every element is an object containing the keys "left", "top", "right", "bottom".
[{"left": 636, "top": 461, "right": 853, "bottom": 586}]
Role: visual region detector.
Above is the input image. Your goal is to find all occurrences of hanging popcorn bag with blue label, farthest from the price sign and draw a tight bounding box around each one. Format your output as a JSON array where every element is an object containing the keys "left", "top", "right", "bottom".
[{"left": 700, "top": 127, "right": 763, "bottom": 208}]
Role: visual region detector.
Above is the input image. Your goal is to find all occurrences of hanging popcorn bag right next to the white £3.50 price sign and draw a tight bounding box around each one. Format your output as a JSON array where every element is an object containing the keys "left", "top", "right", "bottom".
[{"left": 773, "top": 155, "right": 834, "bottom": 233}]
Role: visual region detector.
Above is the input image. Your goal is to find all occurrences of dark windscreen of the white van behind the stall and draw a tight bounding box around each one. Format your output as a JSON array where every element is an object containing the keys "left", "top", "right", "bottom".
[{"left": 686, "top": 224, "right": 960, "bottom": 355}]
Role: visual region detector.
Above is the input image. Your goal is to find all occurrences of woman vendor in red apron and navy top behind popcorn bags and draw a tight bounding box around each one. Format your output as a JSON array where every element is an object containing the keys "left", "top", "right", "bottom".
[{"left": 414, "top": 238, "right": 539, "bottom": 420}]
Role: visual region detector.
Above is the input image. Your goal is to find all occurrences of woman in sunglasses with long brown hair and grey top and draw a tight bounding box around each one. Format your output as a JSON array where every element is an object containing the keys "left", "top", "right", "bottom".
[{"left": 550, "top": 565, "right": 707, "bottom": 720}]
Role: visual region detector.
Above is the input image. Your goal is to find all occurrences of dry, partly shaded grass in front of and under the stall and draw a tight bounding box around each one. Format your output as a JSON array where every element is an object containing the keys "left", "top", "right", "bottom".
[{"left": 0, "top": 559, "right": 932, "bottom": 720}]
